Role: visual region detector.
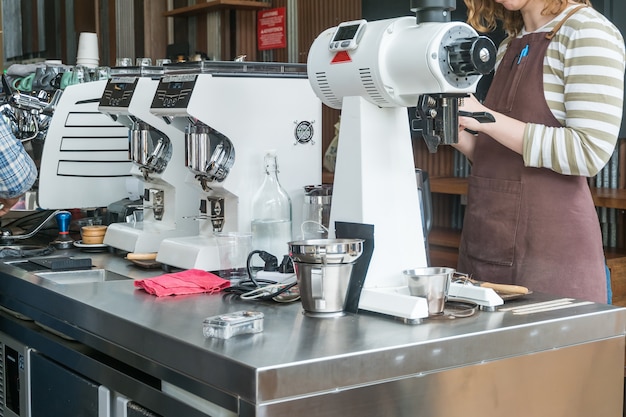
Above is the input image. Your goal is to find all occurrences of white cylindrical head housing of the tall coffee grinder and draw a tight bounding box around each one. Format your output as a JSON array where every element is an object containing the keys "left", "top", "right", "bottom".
[{"left": 307, "top": 16, "right": 481, "bottom": 109}]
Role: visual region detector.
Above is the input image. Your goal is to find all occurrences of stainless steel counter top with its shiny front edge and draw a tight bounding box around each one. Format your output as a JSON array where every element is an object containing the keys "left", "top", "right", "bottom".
[{"left": 0, "top": 247, "right": 626, "bottom": 403}]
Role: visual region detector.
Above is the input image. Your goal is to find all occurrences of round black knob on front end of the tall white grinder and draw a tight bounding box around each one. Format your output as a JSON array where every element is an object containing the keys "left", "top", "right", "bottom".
[{"left": 446, "top": 36, "right": 497, "bottom": 77}]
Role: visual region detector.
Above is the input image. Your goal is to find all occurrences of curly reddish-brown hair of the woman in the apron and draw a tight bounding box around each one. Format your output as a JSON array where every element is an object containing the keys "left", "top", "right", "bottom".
[{"left": 463, "top": 0, "right": 591, "bottom": 36}]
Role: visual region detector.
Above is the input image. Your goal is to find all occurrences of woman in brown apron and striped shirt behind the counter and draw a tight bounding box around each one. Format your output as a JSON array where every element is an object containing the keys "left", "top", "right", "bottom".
[{"left": 456, "top": 0, "right": 625, "bottom": 303}]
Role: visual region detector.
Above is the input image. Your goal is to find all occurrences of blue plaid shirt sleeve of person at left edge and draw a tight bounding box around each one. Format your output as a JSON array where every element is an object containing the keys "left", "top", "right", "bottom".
[{"left": 0, "top": 118, "right": 37, "bottom": 216}]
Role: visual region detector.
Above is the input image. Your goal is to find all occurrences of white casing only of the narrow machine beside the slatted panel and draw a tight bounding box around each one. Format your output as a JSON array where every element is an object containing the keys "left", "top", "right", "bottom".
[{"left": 99, "top": 76, "right": 199, "bottom": 253}]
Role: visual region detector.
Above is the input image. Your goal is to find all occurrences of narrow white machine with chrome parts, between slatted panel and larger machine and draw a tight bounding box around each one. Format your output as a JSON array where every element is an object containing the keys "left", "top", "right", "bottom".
[{"left": 98, "top": 67, "right": 199, "bottom": 253}]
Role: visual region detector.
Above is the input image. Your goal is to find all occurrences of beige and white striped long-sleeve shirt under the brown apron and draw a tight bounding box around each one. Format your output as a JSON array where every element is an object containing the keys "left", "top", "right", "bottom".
[{"left": 496, "top": 5, "right": 626, "bottom": 177}]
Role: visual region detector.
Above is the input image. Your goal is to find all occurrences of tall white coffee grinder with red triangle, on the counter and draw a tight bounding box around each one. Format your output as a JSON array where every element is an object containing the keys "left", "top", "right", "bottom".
[{"left": 308, "top": 0, "right": 496, "bottom": 320}]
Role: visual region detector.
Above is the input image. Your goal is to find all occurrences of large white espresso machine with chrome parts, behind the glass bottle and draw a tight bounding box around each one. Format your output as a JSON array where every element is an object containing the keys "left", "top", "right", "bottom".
[{"left": 151, "top": 61, "right": 322, "bottom": 271}]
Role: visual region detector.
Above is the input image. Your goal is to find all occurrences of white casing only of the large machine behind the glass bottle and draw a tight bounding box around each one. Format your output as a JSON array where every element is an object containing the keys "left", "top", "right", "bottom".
[{"left": 151, "top": 69, "right": 322, "bottom": 271}]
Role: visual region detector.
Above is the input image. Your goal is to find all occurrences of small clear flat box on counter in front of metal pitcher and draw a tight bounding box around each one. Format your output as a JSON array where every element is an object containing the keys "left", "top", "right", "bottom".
[{"left": 202, "top": 311, "right": 263, "bottom": 339}]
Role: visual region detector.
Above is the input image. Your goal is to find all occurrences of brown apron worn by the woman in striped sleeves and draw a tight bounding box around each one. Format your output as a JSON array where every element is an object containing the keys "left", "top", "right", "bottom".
[{"left": 457, "top": 5, "right": 607, "bottom": 303}]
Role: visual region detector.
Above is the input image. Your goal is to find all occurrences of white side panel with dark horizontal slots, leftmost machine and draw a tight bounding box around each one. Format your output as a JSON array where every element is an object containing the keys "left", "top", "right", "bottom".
[{"left": 37, "top": 81, "right": 132, "bottom": 210}]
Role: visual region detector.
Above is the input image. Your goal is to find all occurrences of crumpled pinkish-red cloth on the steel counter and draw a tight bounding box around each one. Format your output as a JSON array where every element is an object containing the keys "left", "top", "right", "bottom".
[{"left": 135, "top": 269, "right": 230, "bottom": 297}]
